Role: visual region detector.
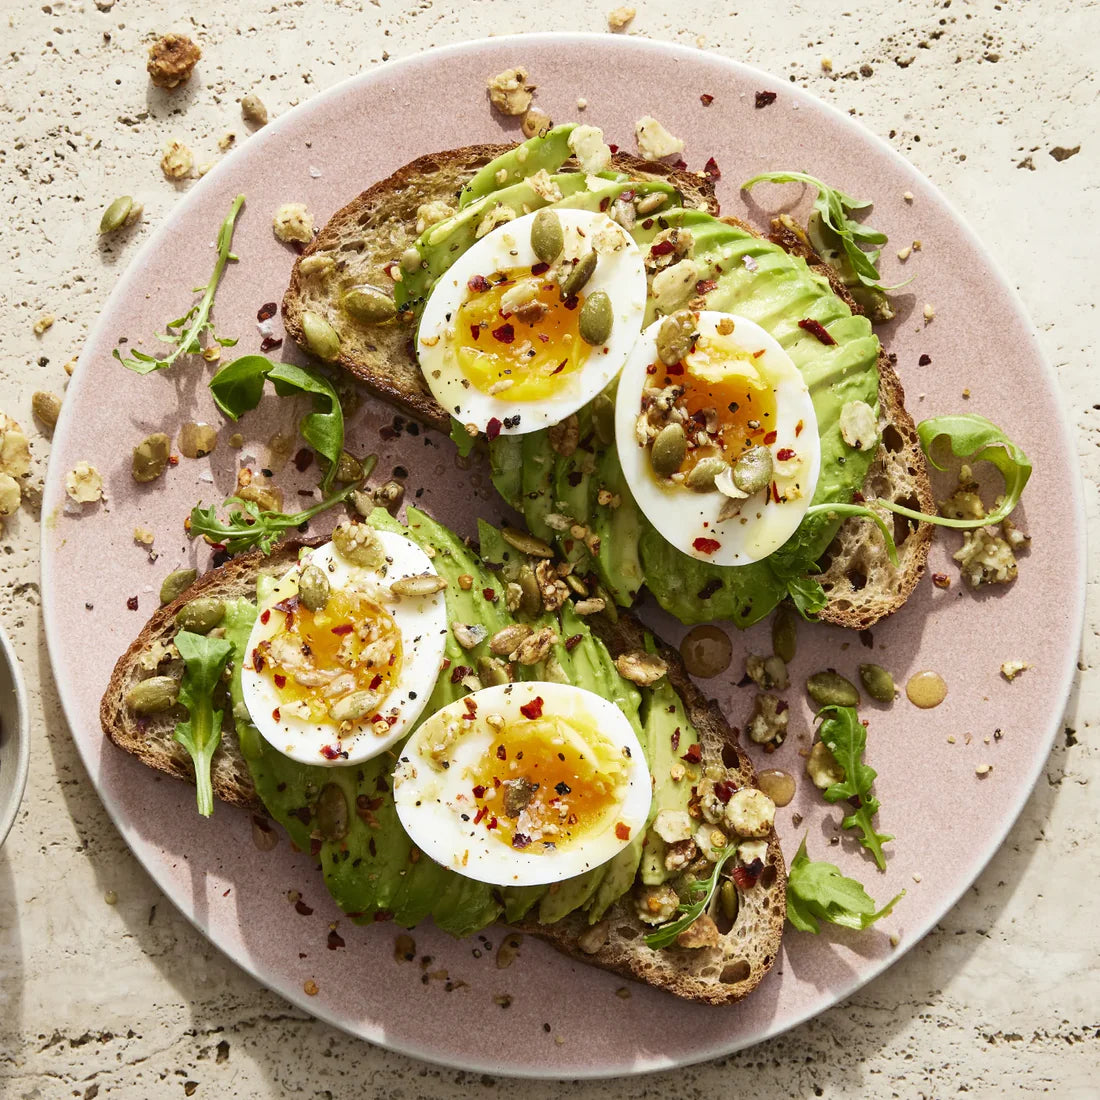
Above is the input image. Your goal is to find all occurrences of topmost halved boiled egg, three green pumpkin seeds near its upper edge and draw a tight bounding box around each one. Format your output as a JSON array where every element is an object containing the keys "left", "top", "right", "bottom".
[{"left": 416, "top": 207, "right": 646, "bottom": 438}]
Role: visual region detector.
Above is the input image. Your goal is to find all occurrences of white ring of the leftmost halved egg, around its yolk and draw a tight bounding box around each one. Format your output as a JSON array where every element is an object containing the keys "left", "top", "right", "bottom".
[{"left": 241, "top": 531, "right": 448, "bottom": 766}]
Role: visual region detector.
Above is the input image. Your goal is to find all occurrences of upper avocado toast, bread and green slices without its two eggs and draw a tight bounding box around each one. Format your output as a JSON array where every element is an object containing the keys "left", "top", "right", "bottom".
[{"left": 283, "top": 127, "right": 934, "bottom": 628}]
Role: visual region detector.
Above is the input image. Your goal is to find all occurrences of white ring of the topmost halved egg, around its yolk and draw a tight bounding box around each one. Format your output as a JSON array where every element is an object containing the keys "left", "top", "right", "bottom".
[{"left": 416, "top": 207, "right": 646, "bottom": 436}]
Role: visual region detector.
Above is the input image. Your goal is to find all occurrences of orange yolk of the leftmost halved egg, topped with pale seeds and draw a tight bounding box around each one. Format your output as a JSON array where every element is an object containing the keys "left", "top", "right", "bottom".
[{"left": 252, "top": 589, "right": 403, "bottom": 722}]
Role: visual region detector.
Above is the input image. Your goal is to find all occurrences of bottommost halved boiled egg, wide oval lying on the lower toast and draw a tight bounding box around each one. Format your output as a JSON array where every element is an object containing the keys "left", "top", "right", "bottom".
[{"left": 394, "top": 682, "right": 652, "bottom": 886}]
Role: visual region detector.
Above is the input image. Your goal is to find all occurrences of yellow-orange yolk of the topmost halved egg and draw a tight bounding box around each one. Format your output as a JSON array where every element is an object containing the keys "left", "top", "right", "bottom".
[{"left": 452, "top": 264, "right": 591, "bottom": 402}]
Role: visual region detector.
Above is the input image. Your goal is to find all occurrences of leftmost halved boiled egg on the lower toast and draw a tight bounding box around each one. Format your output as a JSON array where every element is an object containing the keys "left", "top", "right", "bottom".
[{"left": 241, "top": 524, "right": 447, "bottom": 765}]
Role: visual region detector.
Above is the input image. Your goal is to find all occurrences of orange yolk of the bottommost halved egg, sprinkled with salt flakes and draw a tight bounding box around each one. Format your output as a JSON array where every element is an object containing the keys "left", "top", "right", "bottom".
[{"left": 468, "top": 715, "right": 630, "bottom": 853}]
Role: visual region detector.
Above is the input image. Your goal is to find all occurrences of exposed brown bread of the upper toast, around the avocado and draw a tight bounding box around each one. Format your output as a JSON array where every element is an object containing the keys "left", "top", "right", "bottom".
[{"left": 283, "top": 145, "right": 935, "bottom": 629}]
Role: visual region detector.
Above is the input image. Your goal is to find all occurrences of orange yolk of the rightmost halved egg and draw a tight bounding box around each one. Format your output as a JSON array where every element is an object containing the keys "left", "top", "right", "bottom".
[{"left": 659, "top": 336, "right": 776, "bottom": 474}]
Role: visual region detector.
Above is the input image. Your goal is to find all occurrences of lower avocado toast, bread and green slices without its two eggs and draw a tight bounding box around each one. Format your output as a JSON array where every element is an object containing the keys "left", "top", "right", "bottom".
[{"left": 100, "top": 509, "right": 785, "bottom": 1003}]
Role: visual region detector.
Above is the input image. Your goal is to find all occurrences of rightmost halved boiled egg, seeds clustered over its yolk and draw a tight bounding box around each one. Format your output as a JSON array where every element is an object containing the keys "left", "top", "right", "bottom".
[{"left": 615, "top": 309, "right": 821, "bottom": 565}]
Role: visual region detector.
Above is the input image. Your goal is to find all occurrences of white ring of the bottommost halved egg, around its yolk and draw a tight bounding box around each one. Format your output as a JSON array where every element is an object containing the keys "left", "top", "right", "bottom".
[{"left": 394, "top": 681, "right": 652, "bottom": 886}]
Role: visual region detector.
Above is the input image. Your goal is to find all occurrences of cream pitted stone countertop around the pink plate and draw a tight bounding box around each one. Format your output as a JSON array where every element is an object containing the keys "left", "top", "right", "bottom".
[{"left": 0, "top": 0, "right": 1100, "bottom": 1100}]
